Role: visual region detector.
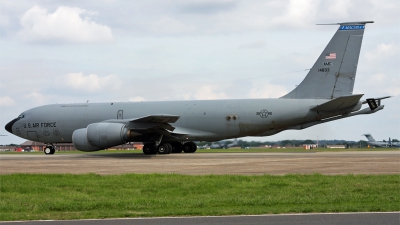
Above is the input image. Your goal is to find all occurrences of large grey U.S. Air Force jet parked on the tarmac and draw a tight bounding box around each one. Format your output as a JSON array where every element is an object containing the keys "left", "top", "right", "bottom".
[{"left": 5, "top": 21, "right": 386, "bottom": 154}]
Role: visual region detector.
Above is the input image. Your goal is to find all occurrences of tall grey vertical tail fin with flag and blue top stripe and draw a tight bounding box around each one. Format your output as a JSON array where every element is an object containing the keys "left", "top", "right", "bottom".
[{"left": 282, "top": 21, "right": 373, "bottom": 99}]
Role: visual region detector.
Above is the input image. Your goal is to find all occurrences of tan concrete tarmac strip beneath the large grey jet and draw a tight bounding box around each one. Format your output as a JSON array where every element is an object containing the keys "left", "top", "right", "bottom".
[{"left": 0, "top": 151, "right": 400, "bottom": 175}]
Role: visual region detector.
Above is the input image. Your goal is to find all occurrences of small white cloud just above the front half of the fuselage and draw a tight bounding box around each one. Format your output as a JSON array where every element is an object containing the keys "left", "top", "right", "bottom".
[{"left": 63, "top": 72, "right": 122, "bottom": 92}]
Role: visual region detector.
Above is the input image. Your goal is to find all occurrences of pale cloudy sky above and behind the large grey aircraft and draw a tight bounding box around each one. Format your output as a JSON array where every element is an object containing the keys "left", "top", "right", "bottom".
[{"left": 0, "top": 0, "right": 400, "bottom": 144}]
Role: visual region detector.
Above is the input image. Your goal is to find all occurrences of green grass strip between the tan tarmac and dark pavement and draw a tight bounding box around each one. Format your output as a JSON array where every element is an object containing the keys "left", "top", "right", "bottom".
[{"left": 0, "top": 174, "right": 400, "bottom": 221}]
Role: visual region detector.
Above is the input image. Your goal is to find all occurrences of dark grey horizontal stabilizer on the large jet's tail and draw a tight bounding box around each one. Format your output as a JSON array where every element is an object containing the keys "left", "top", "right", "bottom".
[{"left": 311, "top": 94, "right": 364, "bottom": 112}]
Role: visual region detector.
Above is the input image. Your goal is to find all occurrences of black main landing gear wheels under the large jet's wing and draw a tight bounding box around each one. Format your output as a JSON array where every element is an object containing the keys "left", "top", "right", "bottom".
[{"left": 143, "top": 142, "right": 197, "bottom": 155}]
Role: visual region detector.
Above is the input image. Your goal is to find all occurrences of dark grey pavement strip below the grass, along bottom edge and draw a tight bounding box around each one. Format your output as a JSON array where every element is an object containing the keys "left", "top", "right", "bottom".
[{"left": 2, "top": 212, "right": 400, "bottom": 225}]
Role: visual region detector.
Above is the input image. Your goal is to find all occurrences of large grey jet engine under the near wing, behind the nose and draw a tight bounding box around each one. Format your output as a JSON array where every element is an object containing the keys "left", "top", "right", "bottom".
[{"left": 72, "top": 123, "right": 136, "bottom": 151}]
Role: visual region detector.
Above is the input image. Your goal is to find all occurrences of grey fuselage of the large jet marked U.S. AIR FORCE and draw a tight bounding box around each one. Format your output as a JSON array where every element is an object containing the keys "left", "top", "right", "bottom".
[{"left": 13, "top": 99, "right": 340, "bottom": 143}]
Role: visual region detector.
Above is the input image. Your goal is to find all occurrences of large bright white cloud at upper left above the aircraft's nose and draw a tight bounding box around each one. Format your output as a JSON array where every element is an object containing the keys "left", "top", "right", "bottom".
[{"left": 18, "top": 6, "right": 113, "bottom": 43}]
